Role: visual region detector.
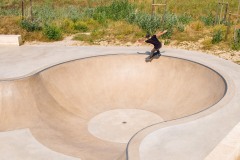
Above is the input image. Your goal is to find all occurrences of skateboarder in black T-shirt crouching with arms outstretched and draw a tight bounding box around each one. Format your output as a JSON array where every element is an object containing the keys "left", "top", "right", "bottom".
[{"left": 142, "top": 30, "right": 167, "bottom": 59}]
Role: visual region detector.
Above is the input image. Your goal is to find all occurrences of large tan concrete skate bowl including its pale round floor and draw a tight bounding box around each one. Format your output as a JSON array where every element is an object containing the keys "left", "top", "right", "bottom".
[{"left": 0, "top": 54, "right": 227, "bottom": 160}]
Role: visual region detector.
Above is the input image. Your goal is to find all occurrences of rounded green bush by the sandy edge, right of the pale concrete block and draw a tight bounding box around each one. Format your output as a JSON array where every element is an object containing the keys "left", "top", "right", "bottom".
[{"left": 43, "top": 24, "right": 62, "bottom": 40}]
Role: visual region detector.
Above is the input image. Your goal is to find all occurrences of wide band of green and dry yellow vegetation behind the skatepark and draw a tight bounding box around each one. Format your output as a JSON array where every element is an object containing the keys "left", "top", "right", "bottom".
[{"left": 0, "top": 0, "right": 240, "bottom": 50}]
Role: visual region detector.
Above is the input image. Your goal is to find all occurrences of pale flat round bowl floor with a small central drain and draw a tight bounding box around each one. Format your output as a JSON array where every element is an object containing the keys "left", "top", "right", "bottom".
[{"left": 88, "top": 109, "right": 164, "bottom": 143}]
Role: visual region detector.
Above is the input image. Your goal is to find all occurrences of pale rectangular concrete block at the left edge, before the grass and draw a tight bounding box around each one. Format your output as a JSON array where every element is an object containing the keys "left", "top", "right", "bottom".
[{"left": 0, "top": 35, "right": 23, "bottom": 46}]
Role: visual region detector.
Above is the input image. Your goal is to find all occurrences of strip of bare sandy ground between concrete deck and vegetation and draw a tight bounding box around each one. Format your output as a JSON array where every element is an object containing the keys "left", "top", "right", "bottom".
[{"left": 25, "top": 36, "right": 240, "bottom": 64}]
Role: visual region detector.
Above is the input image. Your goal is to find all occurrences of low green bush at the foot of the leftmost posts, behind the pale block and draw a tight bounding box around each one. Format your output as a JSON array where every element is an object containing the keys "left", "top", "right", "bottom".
[{"left": 20, "top": 20, "right": 42, "bottom": 32}]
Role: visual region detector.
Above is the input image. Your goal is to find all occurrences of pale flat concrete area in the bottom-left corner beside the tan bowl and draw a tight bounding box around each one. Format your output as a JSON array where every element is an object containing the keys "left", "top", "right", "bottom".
[{"left": 0, "top": 129, "right": 80, "bottom": 160}]
